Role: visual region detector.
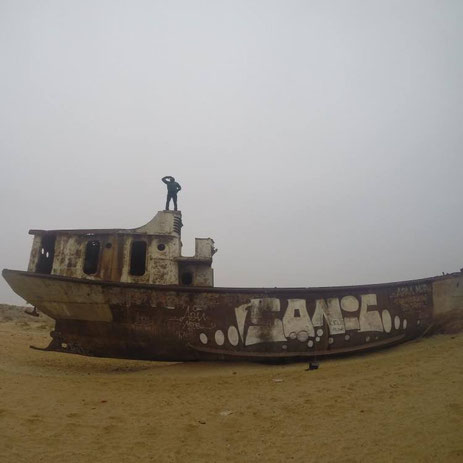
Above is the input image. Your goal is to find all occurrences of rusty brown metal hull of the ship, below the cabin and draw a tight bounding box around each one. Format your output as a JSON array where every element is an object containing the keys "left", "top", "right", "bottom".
[{"left": 3, "top": 270, "right": 463, "bottom": 361}]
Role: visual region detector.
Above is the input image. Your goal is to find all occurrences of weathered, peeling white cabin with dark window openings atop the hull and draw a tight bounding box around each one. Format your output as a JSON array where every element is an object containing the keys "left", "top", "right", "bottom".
[{"left": 28, "top": 211, "right": 216, "bottom": 287}]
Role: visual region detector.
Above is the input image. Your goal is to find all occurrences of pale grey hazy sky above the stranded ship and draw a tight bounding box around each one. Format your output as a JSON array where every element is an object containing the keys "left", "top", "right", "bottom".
[{"left": 0, "top": 0, "right": 463, "bottom": 302}]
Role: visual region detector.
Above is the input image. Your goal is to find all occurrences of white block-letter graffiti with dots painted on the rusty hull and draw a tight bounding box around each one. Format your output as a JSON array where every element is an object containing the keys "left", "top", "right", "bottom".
[{"left": 199, "top": 286, "right": 430, "bottom": 349}]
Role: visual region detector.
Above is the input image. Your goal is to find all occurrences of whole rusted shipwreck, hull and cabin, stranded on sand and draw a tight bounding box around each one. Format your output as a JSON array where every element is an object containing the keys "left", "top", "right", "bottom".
[{"left": 3, "top": 211, "right": 463, "bottom": 360}]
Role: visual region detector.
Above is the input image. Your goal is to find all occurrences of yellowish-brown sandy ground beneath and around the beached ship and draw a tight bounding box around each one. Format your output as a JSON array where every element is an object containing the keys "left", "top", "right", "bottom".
[{"left": 0, "top": 307, "right": 463, "bottom": 463}]
